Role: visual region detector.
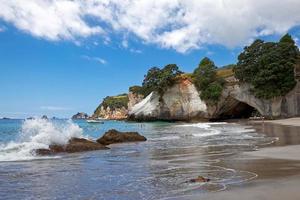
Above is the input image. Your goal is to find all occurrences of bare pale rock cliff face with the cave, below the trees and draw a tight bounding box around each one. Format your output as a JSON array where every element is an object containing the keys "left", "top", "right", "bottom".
[{"left": 129, "top": 77, "right": 300, "bottom": 120}]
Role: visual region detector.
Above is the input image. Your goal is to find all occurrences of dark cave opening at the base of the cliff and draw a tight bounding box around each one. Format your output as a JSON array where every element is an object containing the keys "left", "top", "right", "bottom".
[{"left": 219, "top": 100, "right": 261, "bottom": 119}]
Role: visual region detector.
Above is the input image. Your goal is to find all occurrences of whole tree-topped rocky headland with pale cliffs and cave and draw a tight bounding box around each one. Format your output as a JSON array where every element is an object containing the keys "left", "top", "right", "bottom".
[{"left": 88, "top": 34, "right": 300, "bottom": 121}]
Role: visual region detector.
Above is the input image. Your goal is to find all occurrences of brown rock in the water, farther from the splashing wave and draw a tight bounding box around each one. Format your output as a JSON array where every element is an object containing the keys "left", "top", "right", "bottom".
[{"left": 97, "top": 129, "right": 147, "bottom": 145}]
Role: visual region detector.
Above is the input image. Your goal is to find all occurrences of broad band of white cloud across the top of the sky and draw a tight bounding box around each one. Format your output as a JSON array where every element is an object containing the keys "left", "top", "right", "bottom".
[{"left": 0, "top": 0, "right": 300, "bottom": 52}]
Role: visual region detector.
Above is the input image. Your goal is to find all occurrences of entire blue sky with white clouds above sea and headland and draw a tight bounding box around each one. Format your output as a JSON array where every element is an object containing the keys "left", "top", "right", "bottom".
[{"left": 0, "top": 0, "right": 300, "bottom": 118}]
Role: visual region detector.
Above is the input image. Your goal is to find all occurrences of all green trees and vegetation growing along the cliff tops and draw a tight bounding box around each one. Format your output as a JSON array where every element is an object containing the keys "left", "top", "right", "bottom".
[{"left": 102, "top": 34, "right": 300, "bottom": 113}]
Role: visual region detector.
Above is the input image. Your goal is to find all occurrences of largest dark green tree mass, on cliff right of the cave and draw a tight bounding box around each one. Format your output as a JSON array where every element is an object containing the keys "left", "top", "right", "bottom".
[{"left": 234, "top": 34, "right": 299, "bottom": 99}]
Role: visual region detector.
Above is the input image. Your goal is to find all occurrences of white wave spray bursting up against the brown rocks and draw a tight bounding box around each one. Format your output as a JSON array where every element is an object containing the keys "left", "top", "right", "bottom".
[{"left": 0, "top": 119, "right": 82, "bottom": 161}]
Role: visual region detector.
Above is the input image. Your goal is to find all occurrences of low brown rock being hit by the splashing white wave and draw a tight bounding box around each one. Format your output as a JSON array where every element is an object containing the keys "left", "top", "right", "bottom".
[{"left": 35, "top": 138, "right": 109, "bottom": 155}]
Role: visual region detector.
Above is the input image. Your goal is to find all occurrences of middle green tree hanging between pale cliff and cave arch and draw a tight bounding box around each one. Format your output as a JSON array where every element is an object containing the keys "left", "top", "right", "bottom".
[{"left": 193, "top": 57, "right": 224, "bottom": 104}]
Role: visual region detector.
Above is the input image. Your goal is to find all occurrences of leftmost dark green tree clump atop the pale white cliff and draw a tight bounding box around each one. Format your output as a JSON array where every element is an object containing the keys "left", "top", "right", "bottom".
[{"left": 142, "top": 64, "right": 182, "bottom": 96}]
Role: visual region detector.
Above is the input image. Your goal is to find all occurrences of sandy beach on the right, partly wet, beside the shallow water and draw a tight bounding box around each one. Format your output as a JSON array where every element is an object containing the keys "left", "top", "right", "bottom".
[{"left": 185, "top": 118, "right": 300, "bottom": 200}]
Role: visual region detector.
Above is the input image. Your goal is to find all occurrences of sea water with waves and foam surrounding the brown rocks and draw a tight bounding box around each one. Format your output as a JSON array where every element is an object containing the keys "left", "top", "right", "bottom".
[{"left": 0, "top": 119, "right": 274, "bottom": 199}]
